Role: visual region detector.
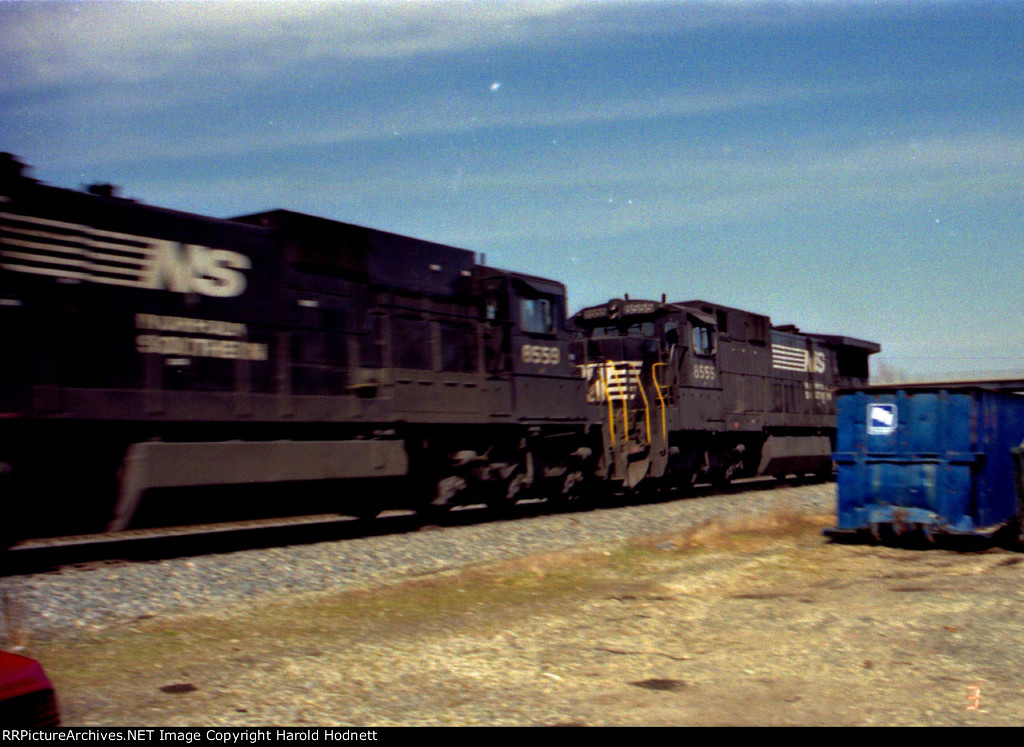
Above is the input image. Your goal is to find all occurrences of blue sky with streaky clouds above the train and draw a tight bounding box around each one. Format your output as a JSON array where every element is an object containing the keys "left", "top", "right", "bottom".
[{"left": 0, "top": 0, "right": 1024, "bottom": 376}]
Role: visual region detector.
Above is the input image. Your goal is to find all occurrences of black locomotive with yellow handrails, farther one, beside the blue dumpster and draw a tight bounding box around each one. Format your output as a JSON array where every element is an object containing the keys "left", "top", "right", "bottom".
[{"left": 572, "top": 296, "right": 881, "bottom": 488}]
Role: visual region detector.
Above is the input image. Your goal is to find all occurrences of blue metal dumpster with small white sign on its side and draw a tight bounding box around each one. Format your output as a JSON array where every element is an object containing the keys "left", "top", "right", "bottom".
[{"left": 826, "top": 385, "right": 1024, "bottom": 536}]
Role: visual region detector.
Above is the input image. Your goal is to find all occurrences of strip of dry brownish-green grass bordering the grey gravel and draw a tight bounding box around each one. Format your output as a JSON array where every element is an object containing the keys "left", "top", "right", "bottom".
[{"left": 14, "top": 511, "right": 831, "bottom": 690}]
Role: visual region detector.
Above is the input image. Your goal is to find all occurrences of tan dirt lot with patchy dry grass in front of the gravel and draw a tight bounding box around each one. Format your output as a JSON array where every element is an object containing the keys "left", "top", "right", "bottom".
[{"left": 16, "top": 515, "right": 1024, "bottom": 727}]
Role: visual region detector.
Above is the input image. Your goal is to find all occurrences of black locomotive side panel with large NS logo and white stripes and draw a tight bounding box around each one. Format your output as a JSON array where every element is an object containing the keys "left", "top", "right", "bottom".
[{"left": 0, "top": 184, "right": 273, "bottom": 419}]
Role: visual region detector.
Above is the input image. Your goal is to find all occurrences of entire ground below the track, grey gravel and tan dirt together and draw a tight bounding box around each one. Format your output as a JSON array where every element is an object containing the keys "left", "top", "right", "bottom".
[{"left": 6, "top": 485, "right": 1024, "bottom": 728}]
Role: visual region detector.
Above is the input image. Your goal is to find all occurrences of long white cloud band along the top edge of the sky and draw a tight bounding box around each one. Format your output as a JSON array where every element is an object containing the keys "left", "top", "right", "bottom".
[{"left": 0, "top": 0, "right": 888, "bottom": 91}]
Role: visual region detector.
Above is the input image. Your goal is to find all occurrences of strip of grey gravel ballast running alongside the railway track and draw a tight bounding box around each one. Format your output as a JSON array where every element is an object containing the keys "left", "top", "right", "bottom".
[{"left": 0, "top": 484, "right": 835, "bottom": 646}]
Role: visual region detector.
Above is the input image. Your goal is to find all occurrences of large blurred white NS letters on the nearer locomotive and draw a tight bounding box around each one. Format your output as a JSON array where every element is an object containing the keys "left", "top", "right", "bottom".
[{"left": 147, "top": 241, "right": 252, "bottom": 298}]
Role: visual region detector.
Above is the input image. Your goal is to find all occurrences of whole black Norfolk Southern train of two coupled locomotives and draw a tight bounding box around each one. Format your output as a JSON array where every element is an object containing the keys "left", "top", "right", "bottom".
[{"left": 0, "top": 154, "right": 881, "bottom": 537}]
